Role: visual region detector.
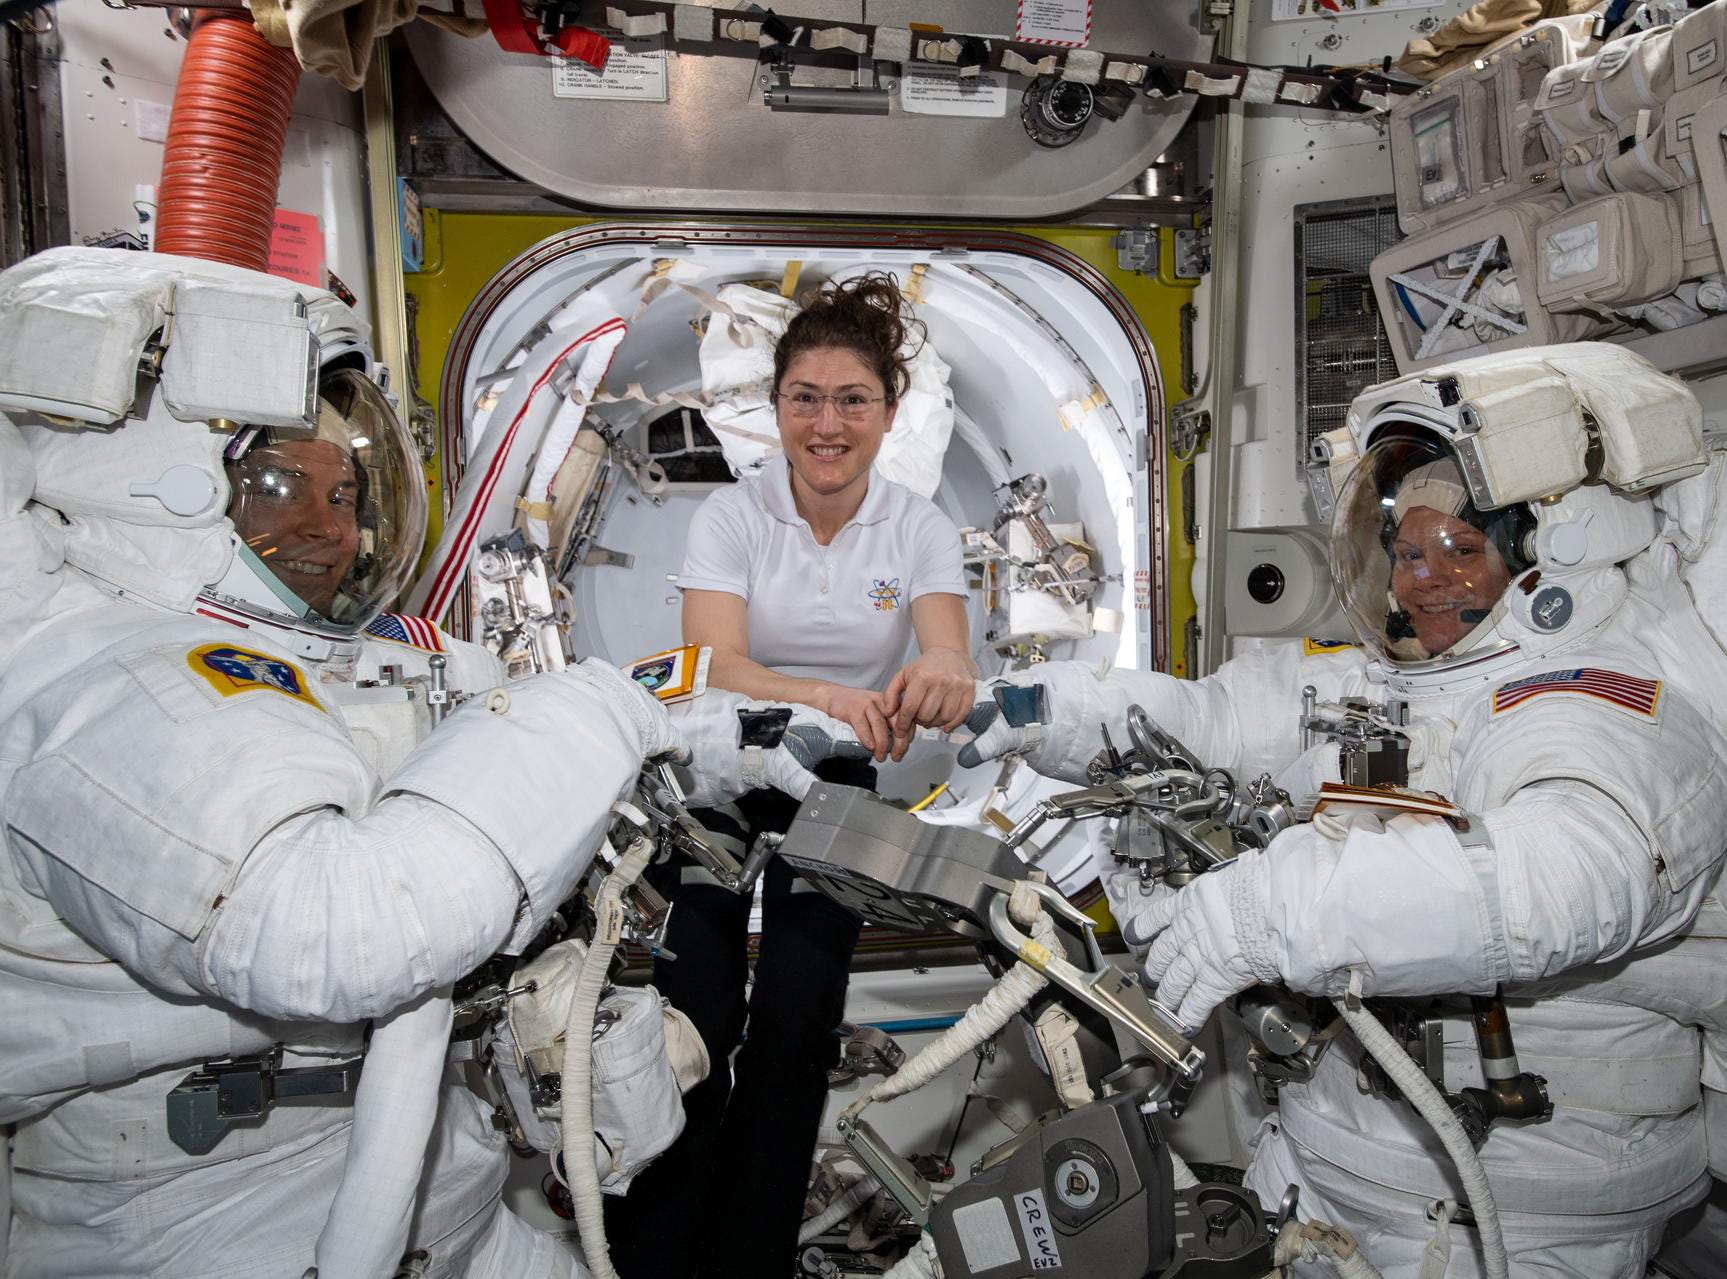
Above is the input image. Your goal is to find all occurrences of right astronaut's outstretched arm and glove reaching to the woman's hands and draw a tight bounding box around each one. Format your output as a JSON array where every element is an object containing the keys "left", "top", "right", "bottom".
[{"left": 962, "top": 644, "right": 1364, "bottom": 782}]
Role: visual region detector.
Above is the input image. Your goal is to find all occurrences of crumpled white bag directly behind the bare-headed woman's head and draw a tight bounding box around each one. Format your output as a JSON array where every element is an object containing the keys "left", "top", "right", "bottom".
[{"left": 701, "top": 285, "right": 953, "bottom": 497}]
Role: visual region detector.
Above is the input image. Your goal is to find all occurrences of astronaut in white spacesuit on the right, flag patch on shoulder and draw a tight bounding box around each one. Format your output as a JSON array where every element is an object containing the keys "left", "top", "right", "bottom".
[{"left": 976, "top": 345, "right": 1727, "bottom": 1279}]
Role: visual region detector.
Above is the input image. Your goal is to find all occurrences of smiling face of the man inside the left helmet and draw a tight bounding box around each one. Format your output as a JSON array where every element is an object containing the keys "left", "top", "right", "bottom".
[{"left": 228, "top": 440, "right": 359, "bottom": 616}]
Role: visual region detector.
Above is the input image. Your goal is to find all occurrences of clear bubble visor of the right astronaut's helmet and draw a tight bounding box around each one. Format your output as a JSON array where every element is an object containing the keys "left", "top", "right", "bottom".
[{"left": 1332, "top": 432, "right": 1532, "bottom": 666}]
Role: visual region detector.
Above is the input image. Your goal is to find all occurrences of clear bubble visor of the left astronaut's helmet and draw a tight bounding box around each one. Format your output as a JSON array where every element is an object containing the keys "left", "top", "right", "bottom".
[{"left": 226, "top": 369, "right": 427, "bottom": 633}]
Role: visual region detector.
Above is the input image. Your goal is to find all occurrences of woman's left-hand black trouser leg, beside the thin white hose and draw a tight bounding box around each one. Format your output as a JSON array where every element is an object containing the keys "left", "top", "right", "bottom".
[{"left": 604, "top": 828, "right": 751, "bottom": 1279}]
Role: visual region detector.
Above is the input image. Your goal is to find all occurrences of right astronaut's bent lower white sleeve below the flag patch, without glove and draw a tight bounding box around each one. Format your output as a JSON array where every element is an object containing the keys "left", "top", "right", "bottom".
[{"left": 1230, "top": 780, "right": 1708, "bottom": 996}]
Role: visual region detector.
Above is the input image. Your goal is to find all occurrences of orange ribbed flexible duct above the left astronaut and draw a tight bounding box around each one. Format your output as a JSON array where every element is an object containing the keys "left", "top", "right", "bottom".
[{"left": 150, "top": 14, "right": 300, "bottom": 271}]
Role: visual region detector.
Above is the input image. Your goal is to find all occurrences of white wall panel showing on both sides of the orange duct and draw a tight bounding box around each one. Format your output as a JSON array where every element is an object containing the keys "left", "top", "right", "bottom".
[{"left": 45, "top": 0, "right": 371, "bottom": 318}]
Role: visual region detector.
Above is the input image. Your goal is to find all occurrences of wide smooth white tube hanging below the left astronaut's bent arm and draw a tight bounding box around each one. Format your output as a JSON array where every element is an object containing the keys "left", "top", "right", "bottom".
[{"left": 314, "top": 987, "right": 451, "bottom": 1279}]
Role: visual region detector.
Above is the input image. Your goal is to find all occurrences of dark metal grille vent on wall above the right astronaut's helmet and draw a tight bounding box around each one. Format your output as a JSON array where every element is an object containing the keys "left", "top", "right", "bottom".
[{"left": 1294, "top": 195, "right": 1401, "bottom": 463}]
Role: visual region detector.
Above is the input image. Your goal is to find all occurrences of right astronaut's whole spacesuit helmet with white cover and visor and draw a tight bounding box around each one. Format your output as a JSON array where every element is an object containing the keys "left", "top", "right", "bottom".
[{"left": 1309, "top": 342, "right": 1706, "bottom": 683}]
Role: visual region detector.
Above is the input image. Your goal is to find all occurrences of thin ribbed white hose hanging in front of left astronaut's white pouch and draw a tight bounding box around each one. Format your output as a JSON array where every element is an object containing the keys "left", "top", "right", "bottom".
[{"left": 554, "top": 839, "right": 653, "bottom": 1279}]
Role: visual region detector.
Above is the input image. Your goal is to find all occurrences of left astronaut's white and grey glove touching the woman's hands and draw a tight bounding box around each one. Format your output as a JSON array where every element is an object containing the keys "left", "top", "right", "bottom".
[{"left": 679, "top": 689, "right": 869, "bottom": 808}]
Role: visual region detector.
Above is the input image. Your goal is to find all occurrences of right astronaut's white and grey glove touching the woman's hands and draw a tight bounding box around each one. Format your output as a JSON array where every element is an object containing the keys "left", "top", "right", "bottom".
[{"left": 958, "top": 661, "right": 1126, "bottom": 785}]
